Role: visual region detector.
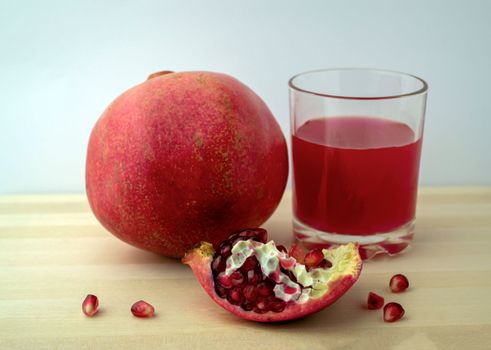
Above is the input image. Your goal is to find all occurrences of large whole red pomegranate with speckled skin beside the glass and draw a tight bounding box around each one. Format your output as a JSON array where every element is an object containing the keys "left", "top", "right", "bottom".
[{"left": 86, "top": 72, "right": 288, "bottom": 257}]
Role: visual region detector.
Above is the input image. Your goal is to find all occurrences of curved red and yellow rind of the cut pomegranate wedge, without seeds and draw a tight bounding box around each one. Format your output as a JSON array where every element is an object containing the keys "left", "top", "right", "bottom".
[{"left": 182, "top": 242, "right": 363, "bottom": 322}]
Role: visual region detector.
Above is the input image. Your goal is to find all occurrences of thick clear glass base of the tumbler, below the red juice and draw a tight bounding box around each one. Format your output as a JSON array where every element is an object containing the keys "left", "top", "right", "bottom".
[{"left": 293, "top": 218, "right": 415, "bottom": 260}]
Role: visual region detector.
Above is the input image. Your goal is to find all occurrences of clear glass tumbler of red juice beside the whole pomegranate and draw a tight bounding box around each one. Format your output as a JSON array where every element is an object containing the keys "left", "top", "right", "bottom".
[{"left": 289, "top": 68, "right": 428, "bottom": 259}]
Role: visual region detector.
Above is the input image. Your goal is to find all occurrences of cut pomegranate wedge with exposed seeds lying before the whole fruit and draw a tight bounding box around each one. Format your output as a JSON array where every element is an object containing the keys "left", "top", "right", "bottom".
[{"left": 183, "top": 229, "right": 362, "bottom": 322}]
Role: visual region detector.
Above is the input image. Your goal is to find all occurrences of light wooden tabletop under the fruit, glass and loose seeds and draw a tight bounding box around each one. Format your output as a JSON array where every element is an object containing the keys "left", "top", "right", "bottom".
[{"left": 0, "top": 188, "right": 491, "bottom": 350}]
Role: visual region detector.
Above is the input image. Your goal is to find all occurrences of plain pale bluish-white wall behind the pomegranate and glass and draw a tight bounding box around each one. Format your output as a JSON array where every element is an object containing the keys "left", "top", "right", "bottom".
[{"left": 0, "top": 0, "right": 491, "bottom": 193}]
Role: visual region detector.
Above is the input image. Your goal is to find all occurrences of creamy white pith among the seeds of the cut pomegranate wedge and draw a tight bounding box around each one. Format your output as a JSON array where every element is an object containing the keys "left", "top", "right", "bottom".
[{"left": 225, "top": 239, "right": 354, "bottom": 304}]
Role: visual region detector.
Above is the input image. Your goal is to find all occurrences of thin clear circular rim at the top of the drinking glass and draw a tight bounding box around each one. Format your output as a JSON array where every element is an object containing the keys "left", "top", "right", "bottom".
[{"left": 288, "top": 67, "right": 428, "bottom": 100}]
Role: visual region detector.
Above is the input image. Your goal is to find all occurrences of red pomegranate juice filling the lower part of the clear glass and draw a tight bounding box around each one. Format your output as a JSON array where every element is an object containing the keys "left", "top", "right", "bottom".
[{"left": 292, "top": 116, "right": 421, "bottom": 235}]
